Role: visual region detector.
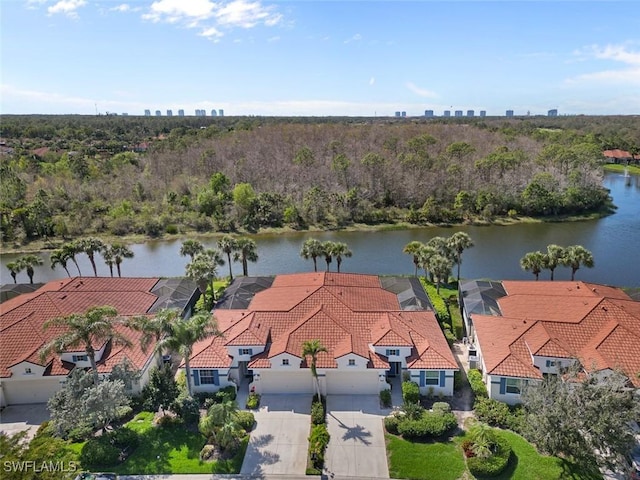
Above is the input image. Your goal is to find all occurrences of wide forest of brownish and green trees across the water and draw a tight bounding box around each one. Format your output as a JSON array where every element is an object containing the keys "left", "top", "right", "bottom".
[{"left": 0, "top": 115, "right": 640, "bottom": 246}]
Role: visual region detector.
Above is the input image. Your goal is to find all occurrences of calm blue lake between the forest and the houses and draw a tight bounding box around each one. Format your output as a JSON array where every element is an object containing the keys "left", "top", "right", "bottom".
[{"left": 1, "top": 173, "right": 640, "bottom": 287}]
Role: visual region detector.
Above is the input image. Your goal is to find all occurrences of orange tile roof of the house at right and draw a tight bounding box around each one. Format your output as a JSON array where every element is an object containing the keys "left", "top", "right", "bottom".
[{"left": 472, "top": 281, "right": 640, "bottom": 387}]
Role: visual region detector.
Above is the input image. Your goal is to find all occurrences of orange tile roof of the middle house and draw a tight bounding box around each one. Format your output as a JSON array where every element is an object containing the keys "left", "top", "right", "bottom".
[{"left": 190, "top": 272, "right": 458, "bottom": 369}]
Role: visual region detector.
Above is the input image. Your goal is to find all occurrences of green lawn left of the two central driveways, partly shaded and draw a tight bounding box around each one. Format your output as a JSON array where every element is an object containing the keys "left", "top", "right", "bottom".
[{"left": 76, "top": 412, "right": 249, "bottom": 475}]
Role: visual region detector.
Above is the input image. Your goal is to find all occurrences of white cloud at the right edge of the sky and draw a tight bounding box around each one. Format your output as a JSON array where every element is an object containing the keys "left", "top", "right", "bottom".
[{"left": 565, "top": 45, "right": 640, "bottom": 86}]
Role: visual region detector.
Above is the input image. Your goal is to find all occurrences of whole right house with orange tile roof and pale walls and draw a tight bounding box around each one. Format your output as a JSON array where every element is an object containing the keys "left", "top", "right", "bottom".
[{"left": 459, "top": 280, "right": 640, "bottom": 404}]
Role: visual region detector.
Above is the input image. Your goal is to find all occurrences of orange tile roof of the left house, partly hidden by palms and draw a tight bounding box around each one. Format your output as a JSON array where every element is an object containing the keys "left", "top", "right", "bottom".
[{"left": 0, "top": 277, "right": 195, "bottom": 377}]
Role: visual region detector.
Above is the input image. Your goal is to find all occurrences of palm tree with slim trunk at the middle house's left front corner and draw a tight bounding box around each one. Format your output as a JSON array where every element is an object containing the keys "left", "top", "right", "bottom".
[{"left": 156, "top": 312, "right": 220, "bottom": 396}]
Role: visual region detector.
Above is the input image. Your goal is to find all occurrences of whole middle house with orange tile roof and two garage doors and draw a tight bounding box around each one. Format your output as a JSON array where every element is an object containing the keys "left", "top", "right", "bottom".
[{"left": 190, "top": 272, "right": 458, "bottom": 396}]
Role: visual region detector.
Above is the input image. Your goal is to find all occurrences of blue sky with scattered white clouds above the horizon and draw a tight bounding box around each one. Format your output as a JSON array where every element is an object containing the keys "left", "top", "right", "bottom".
[{"left": 0, "top": 0, "right": 640, "bottom": 116}]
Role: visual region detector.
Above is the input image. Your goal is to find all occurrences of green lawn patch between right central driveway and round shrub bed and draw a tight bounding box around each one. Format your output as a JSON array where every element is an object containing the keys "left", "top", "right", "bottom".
[{"left": 386, "top": 434, "right": 465, "bottom": 480}]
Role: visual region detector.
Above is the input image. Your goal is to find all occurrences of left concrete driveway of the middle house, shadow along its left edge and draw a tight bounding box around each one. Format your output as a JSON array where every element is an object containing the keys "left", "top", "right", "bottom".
[{"left": 240, "top": 395, "right": 311, "bottom": 476}]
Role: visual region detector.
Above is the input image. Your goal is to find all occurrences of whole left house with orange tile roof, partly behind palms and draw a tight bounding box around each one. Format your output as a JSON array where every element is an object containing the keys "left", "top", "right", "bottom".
[{"left": 0, "top": 277, "right": 199, "bottom": 406}]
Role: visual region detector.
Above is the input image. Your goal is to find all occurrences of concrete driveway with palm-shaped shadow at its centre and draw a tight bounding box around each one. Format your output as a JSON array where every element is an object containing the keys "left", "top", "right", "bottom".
[{"left": 324, "top": 395, "right": 389, "bottom": 478}]
